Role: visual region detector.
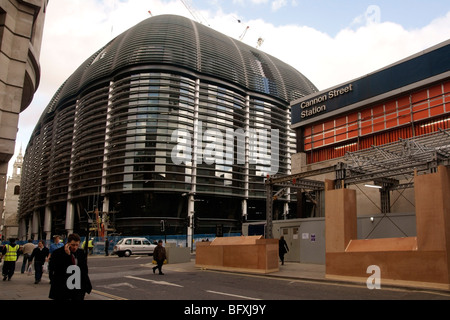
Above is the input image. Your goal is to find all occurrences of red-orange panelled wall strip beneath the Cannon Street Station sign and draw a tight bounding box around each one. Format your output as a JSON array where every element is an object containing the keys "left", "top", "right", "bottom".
[{"left": 303, "top": 81, "right": 450, "bottom": 163}]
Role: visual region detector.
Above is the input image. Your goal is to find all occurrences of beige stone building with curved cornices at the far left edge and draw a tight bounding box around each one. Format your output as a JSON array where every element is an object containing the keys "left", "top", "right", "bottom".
[{"left": 0, "top": 0, "right": 48, "bottom": 235}]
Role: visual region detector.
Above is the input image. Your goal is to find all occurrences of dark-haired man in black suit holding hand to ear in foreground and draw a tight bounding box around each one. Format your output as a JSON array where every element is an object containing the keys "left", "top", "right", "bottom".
[{"left": 48, "top": 233, "right": 92, "bottom": 300}]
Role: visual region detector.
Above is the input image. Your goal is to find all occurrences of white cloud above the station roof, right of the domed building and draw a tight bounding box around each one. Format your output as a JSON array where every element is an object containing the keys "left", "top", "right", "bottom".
[{"left": 237, "top": 12, "right": 450, "bottom": 89}]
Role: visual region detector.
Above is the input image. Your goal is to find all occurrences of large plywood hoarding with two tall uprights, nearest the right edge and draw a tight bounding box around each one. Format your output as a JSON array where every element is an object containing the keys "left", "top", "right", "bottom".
[{"left": 325, "top": 166, "right": 450, "bottom": 290}]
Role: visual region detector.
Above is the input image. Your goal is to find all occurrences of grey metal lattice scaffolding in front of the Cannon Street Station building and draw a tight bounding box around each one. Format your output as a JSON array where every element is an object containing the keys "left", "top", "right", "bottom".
[{"left": 266, "top": 129, "right": 450, "bottom": 238}]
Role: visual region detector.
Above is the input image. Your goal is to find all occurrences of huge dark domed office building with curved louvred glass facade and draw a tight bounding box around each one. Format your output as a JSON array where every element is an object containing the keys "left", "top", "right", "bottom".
[{"left": 19, "top": 15, "right": 317, "bottom": 237}]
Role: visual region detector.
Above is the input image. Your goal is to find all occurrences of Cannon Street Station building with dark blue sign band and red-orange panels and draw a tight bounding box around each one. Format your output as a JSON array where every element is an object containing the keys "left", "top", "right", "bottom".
[{"left": 250, "top": 40, "right": 450, "bottom": 263}]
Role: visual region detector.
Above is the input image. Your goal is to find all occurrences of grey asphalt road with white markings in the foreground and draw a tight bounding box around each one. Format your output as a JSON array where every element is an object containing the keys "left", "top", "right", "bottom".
[{"left": 89, "top": 256, "right": 450, "bottom": 302}]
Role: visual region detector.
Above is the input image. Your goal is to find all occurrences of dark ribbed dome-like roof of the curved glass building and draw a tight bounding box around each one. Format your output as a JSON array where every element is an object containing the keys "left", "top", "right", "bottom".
[{"left": 43, "top": 15, "right": 318, "bottom": 120}]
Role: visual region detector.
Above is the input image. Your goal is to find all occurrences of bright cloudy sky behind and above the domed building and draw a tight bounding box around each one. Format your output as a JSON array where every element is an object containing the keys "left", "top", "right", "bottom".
[{"left": 8, "top": 0, "right": 450, "bottom": 175}]
